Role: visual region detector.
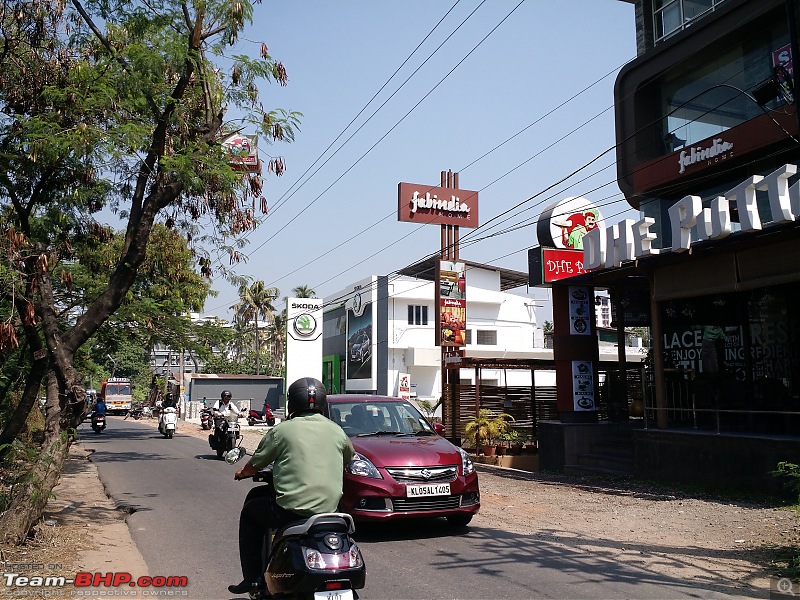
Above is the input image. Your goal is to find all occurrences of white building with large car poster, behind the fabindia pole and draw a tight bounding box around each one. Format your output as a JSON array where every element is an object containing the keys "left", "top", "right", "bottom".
[{"left": 323, "top": 259, "right": 564, "bottom": 403}]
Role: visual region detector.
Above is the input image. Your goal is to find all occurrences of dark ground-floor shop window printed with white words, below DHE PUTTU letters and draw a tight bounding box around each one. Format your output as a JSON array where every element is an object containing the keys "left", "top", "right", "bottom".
[{"left": 660, "top": 284, "right": 800, "bottom": 434}]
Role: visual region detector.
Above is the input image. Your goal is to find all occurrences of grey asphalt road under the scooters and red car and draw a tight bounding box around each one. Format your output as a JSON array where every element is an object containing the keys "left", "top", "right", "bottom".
[{"left": 82, "top": 417, "right": 744, "bottom": 600}]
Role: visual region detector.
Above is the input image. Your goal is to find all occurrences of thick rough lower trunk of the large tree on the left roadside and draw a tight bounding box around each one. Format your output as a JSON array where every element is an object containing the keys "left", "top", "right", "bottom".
[{"left": 0, "top": 373, "right": 70, "bottom": 544}]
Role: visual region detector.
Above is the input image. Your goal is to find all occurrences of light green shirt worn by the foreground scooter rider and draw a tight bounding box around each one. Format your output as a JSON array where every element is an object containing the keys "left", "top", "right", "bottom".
[{"left": 250, "top": 413, "right": 354, "bottom": 516}]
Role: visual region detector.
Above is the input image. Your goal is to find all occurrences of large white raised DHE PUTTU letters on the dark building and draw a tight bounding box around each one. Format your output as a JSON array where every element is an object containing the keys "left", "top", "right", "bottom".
[{"left": 583, "top": 164, "right": 800, "bottom": 270}]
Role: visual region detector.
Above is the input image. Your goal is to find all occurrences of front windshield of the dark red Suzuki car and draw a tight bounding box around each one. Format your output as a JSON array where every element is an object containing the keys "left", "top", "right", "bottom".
[{"left": 329, "top": 400, "right": 434, "bottom": 437}]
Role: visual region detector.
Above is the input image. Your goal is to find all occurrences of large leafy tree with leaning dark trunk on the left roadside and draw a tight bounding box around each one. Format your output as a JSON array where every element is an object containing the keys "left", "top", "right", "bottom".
[{"left": 0, "top": 0, "right": 299, "bottom": 540}]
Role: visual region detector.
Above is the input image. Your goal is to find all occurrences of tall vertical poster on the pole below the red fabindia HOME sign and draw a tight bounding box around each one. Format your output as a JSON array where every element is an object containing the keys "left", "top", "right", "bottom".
[{"left": 436, "top": 260, "right": 467, "bottom": 347}]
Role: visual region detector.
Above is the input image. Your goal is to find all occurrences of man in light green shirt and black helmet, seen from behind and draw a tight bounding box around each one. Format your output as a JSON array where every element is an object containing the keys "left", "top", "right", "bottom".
[{"left": 228, "top": 377, "right": 354, "bottom": 594}]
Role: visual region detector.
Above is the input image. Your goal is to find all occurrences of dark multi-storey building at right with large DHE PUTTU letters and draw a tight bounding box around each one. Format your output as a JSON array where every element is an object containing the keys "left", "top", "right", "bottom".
[{"left": 552, "top": 0, "right": 800, "bottom": 490}]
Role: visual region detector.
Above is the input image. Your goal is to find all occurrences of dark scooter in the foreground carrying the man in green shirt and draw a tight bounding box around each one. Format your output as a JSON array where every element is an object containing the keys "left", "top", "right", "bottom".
[{"left": 225, "top": 446, "right": 367, "bottom": 600}]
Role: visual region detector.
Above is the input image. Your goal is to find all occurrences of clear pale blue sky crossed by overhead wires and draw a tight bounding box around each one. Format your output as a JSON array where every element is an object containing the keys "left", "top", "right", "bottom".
[{"left": 198, "top": 0, "right": 636, "bottom": 324}]
